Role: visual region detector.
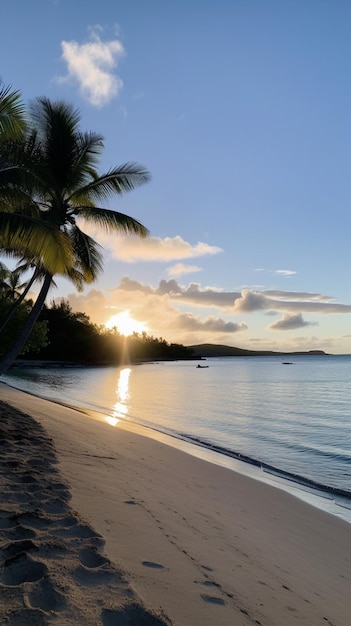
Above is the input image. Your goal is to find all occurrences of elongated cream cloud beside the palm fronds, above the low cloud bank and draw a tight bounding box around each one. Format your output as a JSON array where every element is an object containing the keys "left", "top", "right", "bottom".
[{"left": 96, "top": 235, "right": 222, "bottom": 263}]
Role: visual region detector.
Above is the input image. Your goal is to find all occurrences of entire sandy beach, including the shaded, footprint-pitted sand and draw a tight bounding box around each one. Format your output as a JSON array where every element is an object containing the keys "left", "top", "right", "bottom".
[{"left": 0, "top": 384, "right": 351, "bottom": 626}]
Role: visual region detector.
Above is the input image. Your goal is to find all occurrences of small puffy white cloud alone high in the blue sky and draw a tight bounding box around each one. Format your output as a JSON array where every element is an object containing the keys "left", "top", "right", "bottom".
[{"left": 58, "top": 27, "right": 125, "bottom": 107}]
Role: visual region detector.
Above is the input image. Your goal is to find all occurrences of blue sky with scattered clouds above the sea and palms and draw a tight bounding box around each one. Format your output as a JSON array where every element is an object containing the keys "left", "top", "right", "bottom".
[{"left": 0, "top": 0, "right": 351, "bottom": 354}]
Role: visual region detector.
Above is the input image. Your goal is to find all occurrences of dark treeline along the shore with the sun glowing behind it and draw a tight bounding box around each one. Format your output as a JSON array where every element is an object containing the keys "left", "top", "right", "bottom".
[{"left": 2, "top": 300, "right": 193, "bottom": 365}]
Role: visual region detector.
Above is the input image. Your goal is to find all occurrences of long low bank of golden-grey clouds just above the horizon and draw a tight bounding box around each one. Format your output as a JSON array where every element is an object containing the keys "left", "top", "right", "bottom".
[{"left": 64, "top": 276, "right": 351, "bottom": 351}]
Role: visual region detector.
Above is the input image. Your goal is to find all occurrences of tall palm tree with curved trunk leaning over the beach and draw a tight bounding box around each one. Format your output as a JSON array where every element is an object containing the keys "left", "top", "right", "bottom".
[{"left": 0, "top": 98, "right": 150, "bottom": 374}]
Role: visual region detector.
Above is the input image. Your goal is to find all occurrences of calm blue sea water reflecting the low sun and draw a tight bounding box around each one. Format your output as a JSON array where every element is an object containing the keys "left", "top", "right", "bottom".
[{"left": 4, "top": 356, "right": 351, "bottom": 498}]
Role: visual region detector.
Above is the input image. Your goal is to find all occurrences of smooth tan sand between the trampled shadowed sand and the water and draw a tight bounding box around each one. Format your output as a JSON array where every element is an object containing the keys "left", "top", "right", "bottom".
[{"left": 0, "top": 385, "right": 351, "bottom": 626}]
